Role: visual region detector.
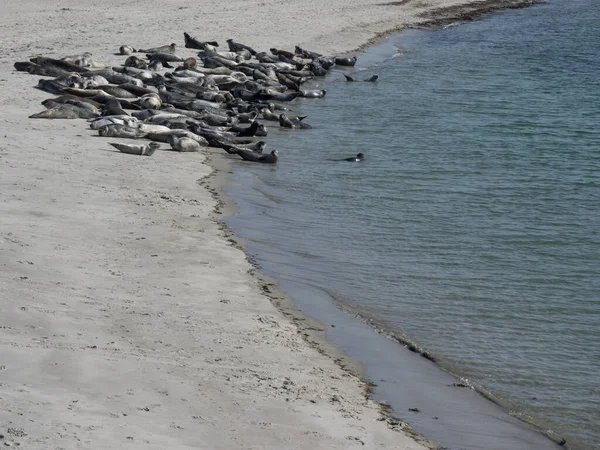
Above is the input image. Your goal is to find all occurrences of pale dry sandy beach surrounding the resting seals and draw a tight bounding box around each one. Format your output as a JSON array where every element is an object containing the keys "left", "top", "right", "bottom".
[{"left": 0, "top": 0, "right": 528, "bottom": 449}]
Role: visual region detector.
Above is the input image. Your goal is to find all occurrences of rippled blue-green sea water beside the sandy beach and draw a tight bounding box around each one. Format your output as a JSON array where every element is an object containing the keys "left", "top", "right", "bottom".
[{"left": 227, "top": 0, "right": 600, "bottom": 449}]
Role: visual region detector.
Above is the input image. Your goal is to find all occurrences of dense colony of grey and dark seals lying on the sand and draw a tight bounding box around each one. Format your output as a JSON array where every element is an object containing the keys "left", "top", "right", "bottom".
[{"left": 14, "top": 33, "right": 376, "bottom": 164}]
